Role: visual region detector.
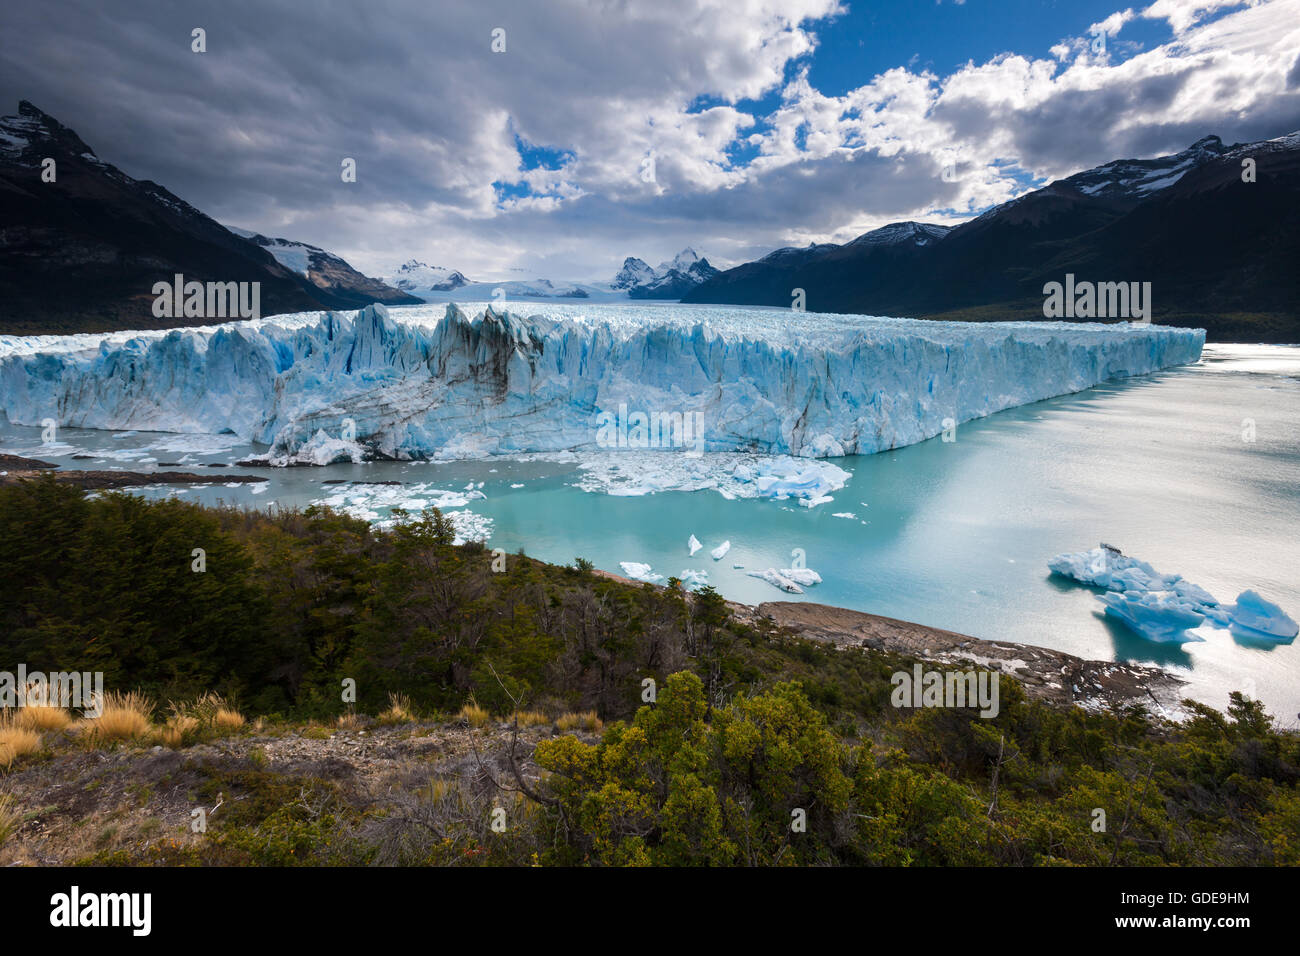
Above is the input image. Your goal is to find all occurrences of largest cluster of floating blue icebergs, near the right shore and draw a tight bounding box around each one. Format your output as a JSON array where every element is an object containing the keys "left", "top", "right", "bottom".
[{"left": 1048, "top": 545, "right": 1300, "bottom": 644}]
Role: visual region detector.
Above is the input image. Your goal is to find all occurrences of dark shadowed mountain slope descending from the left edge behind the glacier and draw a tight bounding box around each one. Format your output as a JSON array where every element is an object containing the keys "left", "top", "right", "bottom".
[{"left": 0, "top": 100, "right": 408, "bottom": 334}]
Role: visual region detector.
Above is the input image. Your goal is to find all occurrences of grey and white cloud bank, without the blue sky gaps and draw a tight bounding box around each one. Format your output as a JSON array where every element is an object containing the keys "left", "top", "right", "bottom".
[{"left": 0, "top": 0, "right": 1300, "bottom": 277}]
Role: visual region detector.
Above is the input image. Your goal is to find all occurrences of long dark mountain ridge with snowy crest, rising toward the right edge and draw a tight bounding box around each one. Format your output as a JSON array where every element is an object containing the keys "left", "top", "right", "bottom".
[{"left": 684, "top": 134, "right": 1300, "bottom": 342}]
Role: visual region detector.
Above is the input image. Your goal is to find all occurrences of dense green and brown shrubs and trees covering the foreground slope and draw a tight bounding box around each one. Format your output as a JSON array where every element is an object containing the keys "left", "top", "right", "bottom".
[{"left": 0, "top": 479, "right": 1300, "bottom": 865}]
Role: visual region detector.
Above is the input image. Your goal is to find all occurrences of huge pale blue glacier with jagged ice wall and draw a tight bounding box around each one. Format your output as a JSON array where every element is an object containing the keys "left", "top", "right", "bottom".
[{"left": 0, "top": 303, "right": 1205, "bottom": 463}]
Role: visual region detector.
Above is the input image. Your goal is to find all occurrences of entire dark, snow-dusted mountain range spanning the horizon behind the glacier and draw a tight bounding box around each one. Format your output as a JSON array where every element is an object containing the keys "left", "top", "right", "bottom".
[{"left": 0, "top": 101, "right": 1300, "bottom": 342}]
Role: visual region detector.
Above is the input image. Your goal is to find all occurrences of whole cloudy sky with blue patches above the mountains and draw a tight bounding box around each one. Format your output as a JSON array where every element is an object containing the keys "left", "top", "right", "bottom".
[{"left": 0, "top": 0, "right": 1300, "bottom": 280}]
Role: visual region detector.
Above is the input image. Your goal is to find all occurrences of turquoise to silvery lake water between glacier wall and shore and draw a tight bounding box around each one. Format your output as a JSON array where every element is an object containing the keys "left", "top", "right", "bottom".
[{"left": 0, "top": 346, "right": 1300, "bottom": 726}]
